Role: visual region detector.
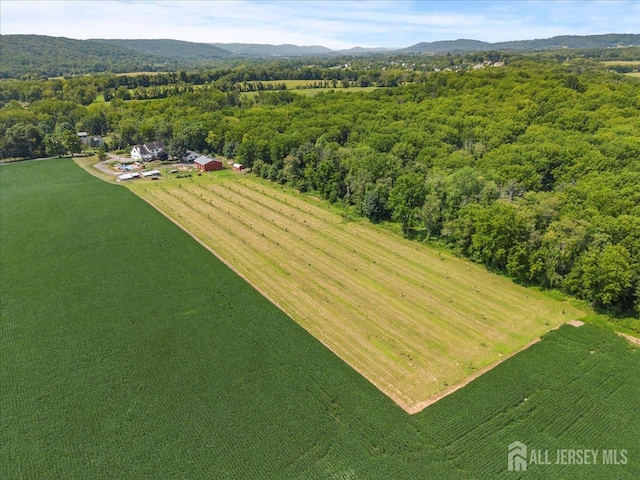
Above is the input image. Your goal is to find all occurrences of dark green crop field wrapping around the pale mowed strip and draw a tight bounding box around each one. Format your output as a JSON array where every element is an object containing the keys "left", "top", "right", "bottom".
[{"left": 0, "top": 160, "right": 640, "bottom": 479}]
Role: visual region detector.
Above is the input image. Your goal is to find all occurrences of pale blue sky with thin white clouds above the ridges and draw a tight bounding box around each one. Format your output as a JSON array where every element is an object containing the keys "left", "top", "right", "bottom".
[{"left": 0, "top": 0, "right": 640, "bottom": 49}]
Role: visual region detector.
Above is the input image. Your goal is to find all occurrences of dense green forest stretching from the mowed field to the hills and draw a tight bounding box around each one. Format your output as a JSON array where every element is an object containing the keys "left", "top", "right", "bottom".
[{"left": 0, "top": 49, "right": 640, "bottom": 317}]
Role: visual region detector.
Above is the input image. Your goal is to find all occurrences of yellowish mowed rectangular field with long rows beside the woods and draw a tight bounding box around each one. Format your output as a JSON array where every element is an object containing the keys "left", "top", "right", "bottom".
[{"left": 130, "top": 175, "right": 583, "bottom": 413}]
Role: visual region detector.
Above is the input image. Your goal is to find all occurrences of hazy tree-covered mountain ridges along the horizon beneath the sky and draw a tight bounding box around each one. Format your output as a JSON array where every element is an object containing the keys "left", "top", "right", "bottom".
[{"left": 0, "top": 34, "right": 640, "bottom": 78}]
